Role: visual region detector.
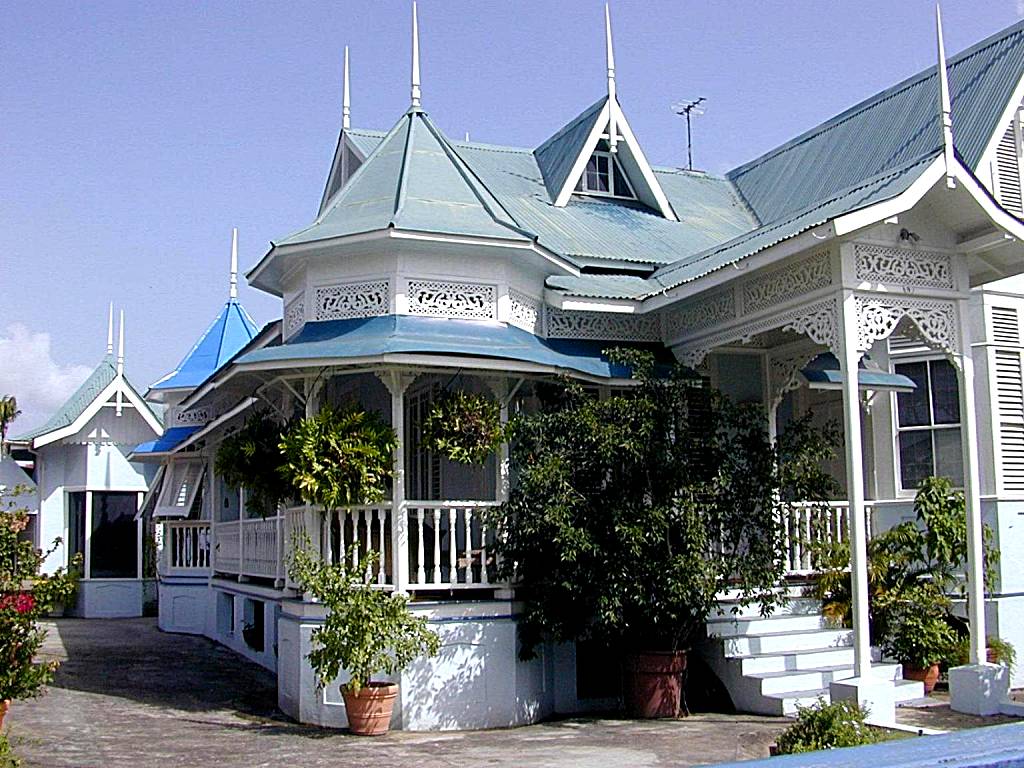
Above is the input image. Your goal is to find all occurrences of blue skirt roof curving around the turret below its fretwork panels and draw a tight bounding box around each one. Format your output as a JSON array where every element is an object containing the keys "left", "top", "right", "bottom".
[{"left": 237, "top": 314, "right": 665, "bottom": 378}]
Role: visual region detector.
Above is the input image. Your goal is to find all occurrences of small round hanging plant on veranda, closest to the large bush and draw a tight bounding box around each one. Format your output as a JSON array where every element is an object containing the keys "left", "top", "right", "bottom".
[{"left": 423, "top": 391, "right": 503, "bottom": 464}]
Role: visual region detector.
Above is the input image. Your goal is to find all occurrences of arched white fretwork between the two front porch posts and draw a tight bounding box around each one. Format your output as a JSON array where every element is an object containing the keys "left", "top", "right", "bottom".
[{"left": 855, "top": 294, "right": 961, "bottom": 353}]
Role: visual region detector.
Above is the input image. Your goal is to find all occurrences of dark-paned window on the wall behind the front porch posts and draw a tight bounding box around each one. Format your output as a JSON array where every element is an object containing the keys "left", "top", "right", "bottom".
[{"left": 894, "top": 359, "right": 964, "bottom": 490}]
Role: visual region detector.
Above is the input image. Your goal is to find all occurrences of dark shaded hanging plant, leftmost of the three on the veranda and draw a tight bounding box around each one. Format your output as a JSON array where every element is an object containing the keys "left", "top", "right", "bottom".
[{"left": 214, "top": 413, "right": 293, "bottom": 516}]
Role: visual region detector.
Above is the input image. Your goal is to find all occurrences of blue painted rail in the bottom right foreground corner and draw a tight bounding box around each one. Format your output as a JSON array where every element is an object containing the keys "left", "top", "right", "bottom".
[{"left": 717, "top": 723, "right": 1024, "bottom": 768}]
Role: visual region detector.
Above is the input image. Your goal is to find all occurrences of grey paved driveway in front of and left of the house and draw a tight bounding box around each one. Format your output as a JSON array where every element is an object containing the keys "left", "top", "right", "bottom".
[{"left": 7, "top": 618, "right": 786, "bottom": 768}]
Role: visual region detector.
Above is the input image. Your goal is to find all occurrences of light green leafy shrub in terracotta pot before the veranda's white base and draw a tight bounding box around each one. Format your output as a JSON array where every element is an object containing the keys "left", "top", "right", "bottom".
[{"left": 290, "top": 543, "right": 439, "bottom": 736}]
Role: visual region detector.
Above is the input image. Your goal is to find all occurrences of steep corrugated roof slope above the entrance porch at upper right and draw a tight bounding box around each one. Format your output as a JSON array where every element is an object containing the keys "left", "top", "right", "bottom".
[{"left": 727, "top": 22, "right": 1024, "bottom": 223}]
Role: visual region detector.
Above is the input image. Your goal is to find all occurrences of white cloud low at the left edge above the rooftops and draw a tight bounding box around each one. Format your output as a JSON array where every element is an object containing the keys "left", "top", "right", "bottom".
[{"left": 0, "top": 323, "right": 92, "bottom": 435}]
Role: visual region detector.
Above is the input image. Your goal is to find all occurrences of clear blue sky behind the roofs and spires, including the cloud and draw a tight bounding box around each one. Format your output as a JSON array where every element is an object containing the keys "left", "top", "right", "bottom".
[{"left": 0, "top": 0, "right": 1024, "bottom": 433}]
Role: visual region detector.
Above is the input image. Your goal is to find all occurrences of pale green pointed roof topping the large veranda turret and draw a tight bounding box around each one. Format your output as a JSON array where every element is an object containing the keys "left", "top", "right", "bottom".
[{"left": 275, "top": 108, "right": 532, "bottom": 246}]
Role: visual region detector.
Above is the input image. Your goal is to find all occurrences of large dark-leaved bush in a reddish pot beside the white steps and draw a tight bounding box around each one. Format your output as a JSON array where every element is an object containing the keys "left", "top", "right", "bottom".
[{"left": 488, "top": 351, "right": 831, "bottom": 717}]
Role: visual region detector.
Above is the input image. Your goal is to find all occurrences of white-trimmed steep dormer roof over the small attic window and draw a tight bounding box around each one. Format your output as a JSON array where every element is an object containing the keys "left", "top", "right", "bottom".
[{"left": 534, "top": 97, "right": 679, "bottom": 221}]
